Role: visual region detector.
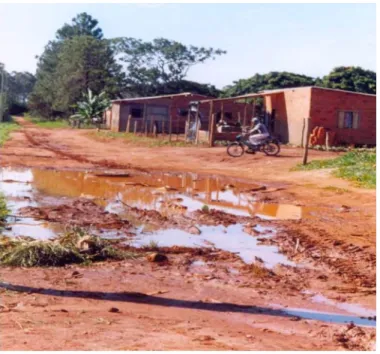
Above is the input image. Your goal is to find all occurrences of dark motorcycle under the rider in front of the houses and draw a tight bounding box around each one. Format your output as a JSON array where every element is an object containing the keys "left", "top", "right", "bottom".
[{"left": 227, "top": 134, "right": 280, "bottom": 157}]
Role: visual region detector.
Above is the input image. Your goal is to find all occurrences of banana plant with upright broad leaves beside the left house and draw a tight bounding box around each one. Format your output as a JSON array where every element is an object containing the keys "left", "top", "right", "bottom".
[{"left": 70, "top": 89, "right": 111, "bottom": 128}]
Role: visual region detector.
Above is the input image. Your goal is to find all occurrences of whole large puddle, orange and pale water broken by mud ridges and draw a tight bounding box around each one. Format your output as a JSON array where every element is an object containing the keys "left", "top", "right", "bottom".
[{"left": 0, "top": 168, "right": 303, "bottom": 268}]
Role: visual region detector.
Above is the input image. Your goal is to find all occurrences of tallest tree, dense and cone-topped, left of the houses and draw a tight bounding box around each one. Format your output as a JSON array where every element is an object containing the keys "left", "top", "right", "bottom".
[{"left": 29, "top": 13, "right": 125, "bottom": 118}]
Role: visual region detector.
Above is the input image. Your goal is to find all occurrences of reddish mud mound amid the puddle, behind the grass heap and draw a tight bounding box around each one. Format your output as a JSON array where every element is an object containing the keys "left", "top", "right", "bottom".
[{"left": 20, "top": 199, "right": 130, "bottom": 229}]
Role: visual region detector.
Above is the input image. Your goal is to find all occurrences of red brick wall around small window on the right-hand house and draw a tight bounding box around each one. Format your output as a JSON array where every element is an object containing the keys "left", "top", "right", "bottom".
[{"left": 310, "top": 87, "right": 376, "bottom": 145}]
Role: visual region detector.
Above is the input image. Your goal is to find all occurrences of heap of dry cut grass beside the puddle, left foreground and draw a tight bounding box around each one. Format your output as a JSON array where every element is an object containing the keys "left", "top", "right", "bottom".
[{"left": 0, "top": 228, "right": 135, "bottom": 267}]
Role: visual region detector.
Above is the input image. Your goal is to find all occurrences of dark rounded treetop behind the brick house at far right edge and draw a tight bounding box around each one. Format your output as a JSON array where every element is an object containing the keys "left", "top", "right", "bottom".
[{"left": 318, "top": 66, "right": 376, "bottom": 94}]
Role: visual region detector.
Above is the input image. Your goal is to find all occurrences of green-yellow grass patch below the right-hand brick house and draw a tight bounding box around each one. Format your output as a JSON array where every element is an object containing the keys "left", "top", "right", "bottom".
[{"left": 293, "top": 151, "right": 376, "bottom": 188}]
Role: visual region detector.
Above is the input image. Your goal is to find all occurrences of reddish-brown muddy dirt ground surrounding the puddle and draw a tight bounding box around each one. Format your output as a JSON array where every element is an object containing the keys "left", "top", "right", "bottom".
[{"left": 0, "top": 118, "right": 376, "bottom": 350}]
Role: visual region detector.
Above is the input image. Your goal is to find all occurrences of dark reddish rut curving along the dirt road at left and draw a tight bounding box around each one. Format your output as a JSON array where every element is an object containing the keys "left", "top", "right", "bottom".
[{"left": 23, "top": 130, "right": 148, "bottom": 172}]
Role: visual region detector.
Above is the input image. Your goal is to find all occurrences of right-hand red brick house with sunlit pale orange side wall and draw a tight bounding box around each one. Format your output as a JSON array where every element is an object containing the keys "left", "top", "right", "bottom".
[{"left": 257, "top": 86, "right": 376, "bottom": 145}]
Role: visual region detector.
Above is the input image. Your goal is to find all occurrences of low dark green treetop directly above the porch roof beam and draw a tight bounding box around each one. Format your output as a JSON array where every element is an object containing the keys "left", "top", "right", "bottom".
[{"left": 223, "top": 71, "right": 315, "bottom": 97}]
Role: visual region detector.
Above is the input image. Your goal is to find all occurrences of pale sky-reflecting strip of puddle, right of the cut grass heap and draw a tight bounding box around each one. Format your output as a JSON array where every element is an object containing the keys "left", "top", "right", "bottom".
[{"left": 131, "top": 224, "right": 295, "bottom": 268}]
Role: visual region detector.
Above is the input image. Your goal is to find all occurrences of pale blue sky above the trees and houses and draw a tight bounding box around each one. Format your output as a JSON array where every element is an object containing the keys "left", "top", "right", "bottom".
[{"left": 0, "top": 4, "right": 376, "bottom": 88}]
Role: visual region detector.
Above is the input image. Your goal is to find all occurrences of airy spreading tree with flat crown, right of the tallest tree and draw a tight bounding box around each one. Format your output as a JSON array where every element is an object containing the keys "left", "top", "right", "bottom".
[{"left": 112, "top": 38, "right": 226, "bottom": 96}]
